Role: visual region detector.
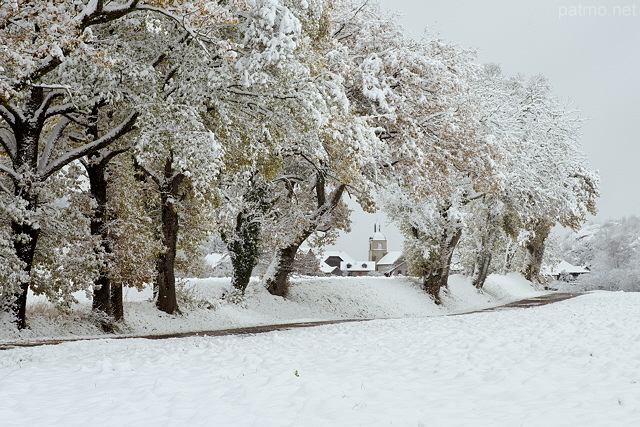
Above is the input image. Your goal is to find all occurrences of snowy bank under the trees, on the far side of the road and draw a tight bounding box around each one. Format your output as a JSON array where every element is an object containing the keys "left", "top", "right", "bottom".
[{"left": 0, "top": 275, "right": 540, "bottom": 342}]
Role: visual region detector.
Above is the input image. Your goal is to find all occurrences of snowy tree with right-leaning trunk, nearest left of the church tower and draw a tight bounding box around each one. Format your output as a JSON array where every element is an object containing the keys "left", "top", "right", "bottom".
[{"left": 215, "top": 1, "right": 374, "bottom": 295}]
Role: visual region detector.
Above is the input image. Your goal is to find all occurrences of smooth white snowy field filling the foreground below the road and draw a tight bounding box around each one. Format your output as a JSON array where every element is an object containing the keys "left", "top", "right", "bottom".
[{"left": 0, "top": 292, "right": 640, "bottom": 426}]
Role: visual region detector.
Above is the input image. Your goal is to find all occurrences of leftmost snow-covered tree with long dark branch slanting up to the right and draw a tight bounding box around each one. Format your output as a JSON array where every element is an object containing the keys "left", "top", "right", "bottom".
[{"left": 0, "top": 0, "right": 243, "bottom": 328}]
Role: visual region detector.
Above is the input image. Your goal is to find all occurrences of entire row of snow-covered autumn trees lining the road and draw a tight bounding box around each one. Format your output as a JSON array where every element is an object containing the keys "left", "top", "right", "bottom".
[{"left": 0, "top": 0, "right": 598, "bottom": 330}]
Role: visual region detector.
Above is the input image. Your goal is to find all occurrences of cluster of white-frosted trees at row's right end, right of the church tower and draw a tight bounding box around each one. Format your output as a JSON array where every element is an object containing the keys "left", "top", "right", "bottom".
[{"left": 385, "top": 66, "right": 599, "bottom": 300}]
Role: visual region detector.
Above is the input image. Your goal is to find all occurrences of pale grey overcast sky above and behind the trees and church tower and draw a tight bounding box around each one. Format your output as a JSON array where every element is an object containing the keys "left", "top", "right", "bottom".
[{"left": 332, "top": 0, "right": 640, "bottom": 259}]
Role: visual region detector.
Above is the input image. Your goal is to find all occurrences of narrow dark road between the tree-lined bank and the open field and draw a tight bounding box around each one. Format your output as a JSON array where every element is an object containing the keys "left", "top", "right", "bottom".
[{"left": 0, "top": 292, "right": 584, "bottom": 350}]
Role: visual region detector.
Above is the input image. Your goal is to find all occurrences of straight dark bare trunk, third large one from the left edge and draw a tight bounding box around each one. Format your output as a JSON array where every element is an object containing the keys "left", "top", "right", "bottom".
[{"left": 156, "top": 157, "right": 184, "bottom": 314}]
